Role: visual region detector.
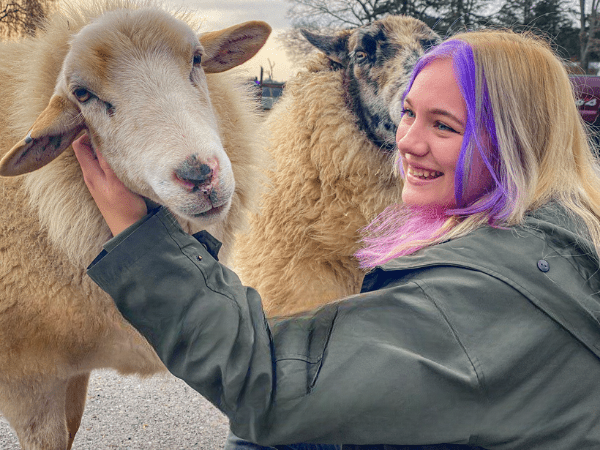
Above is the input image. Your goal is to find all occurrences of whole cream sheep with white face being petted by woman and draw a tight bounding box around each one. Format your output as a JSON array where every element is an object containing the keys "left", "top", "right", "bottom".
[{"left": 0, "top": 0, "right": 270, "bottom": 450}]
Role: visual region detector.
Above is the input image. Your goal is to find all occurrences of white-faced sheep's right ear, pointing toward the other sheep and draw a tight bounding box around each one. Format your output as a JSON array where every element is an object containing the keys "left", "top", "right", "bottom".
[{"left": 200, "top": 21, "right": 271, "bottom": 73}]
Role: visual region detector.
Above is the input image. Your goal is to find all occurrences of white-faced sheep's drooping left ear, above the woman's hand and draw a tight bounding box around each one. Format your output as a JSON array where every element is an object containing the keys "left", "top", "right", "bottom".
[{"left": 0, "top": 95, "right": 84, "bottom": 177}]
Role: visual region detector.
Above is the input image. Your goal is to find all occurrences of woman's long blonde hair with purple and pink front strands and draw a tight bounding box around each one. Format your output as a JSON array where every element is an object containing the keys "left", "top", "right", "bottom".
[{"left": 356, "top": 30, "right": 600, "bottom": 267}]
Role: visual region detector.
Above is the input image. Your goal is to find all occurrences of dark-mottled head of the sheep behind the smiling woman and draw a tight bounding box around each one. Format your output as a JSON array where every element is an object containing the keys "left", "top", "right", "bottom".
[{"left": 302, "top": 16, "right": 439, "bottom": 152}]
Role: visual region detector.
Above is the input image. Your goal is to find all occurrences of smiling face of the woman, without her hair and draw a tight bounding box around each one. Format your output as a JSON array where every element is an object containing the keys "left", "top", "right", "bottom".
[{"left": 396, "top": 58, "right": 491, "bottom": 208}]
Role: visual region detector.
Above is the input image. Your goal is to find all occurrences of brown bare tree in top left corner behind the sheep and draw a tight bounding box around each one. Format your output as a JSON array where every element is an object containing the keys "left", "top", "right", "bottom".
[{"left": 0, "top": 0, "right": 49, "bottom": 38}]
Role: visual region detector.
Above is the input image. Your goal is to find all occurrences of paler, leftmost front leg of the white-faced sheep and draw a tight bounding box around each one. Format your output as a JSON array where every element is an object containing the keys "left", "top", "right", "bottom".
[{"left": 0, "top": 379, "right": 68, "bottom": 450}]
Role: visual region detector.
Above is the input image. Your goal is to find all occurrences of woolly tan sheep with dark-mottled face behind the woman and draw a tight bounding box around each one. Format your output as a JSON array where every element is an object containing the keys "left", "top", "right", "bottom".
[{"left": 235, "top": 16, "right": 438, "bottom": 316}]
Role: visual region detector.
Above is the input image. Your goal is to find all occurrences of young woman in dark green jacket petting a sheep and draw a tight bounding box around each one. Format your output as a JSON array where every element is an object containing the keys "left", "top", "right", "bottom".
[{"left": 74, "top": 32, "right": 600, "bottom": 450}]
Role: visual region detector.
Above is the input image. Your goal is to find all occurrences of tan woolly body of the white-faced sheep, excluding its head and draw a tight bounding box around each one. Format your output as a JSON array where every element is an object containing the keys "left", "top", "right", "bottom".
[{"left": 0, "top": 0, "right": 270, "bottom": 450}]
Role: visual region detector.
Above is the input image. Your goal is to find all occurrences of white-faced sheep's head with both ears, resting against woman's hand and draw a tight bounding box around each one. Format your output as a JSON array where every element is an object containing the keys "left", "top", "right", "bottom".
[{"left": 0, "top": 8, "right": 271, "bottom": 224}]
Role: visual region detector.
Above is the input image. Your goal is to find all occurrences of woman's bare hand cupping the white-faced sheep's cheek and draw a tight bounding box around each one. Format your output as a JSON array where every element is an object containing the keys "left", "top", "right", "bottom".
[{"left": 73, "top": 134, "right": 148, "bottom": 236}]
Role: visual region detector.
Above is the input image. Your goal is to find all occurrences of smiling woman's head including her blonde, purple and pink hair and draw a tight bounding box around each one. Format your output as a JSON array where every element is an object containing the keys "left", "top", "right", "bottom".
[{"left": 356, "top": 31, "right": 600, "bottom": 267}]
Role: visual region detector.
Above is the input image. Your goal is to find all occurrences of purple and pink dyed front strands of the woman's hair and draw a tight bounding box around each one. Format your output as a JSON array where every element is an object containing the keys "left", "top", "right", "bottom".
[{"left": 355, "top": 40, "right": 512, "bottom": 268}]
